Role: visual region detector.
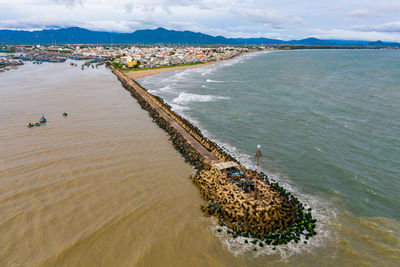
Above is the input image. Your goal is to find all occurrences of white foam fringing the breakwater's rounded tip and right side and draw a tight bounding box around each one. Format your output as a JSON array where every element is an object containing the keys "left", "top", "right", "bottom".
[{"left": 173, "top": 114, "right": 336, "bottom": 259}]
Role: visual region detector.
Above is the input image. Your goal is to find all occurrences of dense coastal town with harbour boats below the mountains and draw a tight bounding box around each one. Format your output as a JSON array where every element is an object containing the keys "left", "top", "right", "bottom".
[{"left": 0, "top": 45, "right": 271, "bottom": 72}]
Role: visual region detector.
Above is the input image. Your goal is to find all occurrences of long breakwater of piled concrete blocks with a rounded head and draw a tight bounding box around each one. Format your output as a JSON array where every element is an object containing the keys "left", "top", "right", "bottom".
[{"left": 112, "top": 68, "right": 317, "bottom": 247}]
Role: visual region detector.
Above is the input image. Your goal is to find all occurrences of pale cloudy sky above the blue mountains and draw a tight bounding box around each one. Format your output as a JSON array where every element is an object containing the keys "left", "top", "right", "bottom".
[{"left": 0, "top": 0, "right": 400, "bottom": 42}]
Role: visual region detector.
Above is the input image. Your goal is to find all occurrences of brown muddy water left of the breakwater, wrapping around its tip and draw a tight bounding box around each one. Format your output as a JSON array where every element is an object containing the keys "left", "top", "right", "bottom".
[{"left": 0, "top": 63, "right": 400, "bottom": 266}]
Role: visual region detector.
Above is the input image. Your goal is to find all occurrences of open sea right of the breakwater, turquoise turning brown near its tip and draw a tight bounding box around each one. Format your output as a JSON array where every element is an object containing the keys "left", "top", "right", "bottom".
[{"left": 139, "top": 50, "right": 400, "bottom": 263}]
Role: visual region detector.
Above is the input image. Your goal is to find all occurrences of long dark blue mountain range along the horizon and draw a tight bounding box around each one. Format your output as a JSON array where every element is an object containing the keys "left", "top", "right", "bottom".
[{"left": 0, "top": 27, "right": 400, "bottom": 47}]
